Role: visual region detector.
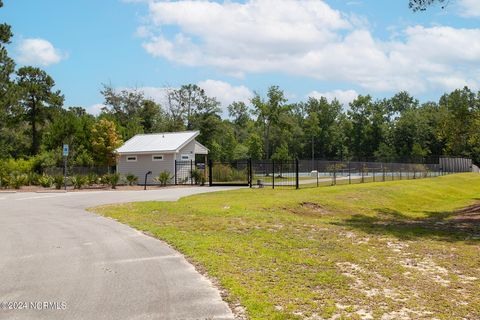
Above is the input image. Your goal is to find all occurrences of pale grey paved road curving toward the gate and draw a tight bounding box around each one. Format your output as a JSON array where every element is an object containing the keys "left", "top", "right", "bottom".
[{"left": 0, "top": 187, "right": 239, "bottom": 320}]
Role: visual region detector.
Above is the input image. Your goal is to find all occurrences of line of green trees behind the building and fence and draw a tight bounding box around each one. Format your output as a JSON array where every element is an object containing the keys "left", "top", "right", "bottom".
[{"left": 0, "top": 1, "right": 480, "bottom": 169}]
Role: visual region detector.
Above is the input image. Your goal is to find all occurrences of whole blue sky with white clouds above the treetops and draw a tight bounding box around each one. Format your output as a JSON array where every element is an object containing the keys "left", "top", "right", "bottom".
[{"left": 0, "top": 0, "right": 480, "bottom": 114}]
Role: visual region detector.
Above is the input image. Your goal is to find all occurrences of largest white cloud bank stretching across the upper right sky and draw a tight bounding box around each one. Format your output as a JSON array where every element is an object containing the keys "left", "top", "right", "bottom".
[{"left": 134, "top": 0, "right": 480, "bottom": 93}]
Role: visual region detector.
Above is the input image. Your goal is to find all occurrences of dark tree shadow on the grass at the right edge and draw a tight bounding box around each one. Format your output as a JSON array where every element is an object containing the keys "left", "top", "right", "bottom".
[{"left": 333, "top": 204, "right": 480, "bottom": 245}]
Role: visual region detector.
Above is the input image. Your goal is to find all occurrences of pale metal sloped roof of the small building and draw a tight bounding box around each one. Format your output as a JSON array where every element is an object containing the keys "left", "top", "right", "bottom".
[{"left": 117, "top": 131, "right": 199, "bottom": 154}]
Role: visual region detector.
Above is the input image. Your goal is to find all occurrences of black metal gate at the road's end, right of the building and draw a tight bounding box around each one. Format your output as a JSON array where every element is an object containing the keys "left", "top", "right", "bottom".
[{"left": 208, "top": 160, "right": 252, "bottom": 186}]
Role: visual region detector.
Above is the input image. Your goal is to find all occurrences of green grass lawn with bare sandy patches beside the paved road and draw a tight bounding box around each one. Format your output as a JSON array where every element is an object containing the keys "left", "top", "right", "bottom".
[{"left": 93, "top": 174, "right": 480, "bottom": 319}]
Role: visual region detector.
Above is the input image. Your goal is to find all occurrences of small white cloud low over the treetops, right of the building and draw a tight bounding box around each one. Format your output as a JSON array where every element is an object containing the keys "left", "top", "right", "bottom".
[{"left": 198, "top": 80, "right": 253, "bottom": 109}]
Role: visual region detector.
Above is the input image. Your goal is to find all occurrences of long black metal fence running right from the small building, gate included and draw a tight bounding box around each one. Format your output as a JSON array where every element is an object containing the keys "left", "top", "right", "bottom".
[{"left": 169, "top": 160, "right": 469, "bottom": 189}]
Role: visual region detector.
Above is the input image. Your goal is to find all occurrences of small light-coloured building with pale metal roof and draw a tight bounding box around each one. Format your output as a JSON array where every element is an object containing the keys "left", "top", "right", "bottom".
[{"left": 117, "top": 131, "right": 208, "bottom": 184}]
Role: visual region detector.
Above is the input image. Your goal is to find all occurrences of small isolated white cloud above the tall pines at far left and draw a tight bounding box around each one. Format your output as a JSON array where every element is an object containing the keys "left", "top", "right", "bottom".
[{"left": 17, "top": 39, "right": 66, "bottom": 67}]
